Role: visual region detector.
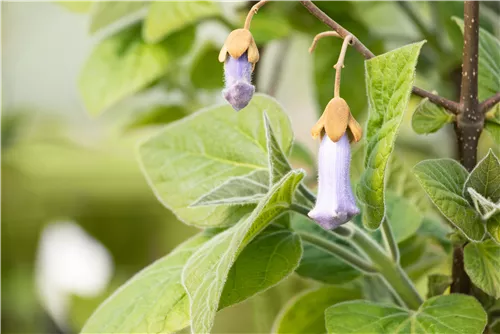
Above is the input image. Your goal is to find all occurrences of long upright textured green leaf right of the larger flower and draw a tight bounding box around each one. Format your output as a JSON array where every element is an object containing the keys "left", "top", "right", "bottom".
[{"left": 357, "top": 42, "right": 423, "bottom": 229}]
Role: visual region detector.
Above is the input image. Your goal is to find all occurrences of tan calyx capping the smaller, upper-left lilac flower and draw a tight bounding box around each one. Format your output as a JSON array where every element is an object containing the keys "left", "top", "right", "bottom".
[{"left": 219, "top": 29, "right": 259, "bottom": 65}]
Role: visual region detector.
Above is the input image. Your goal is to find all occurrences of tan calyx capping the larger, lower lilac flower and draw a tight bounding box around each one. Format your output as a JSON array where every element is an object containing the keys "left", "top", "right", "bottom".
[{"left": 311, "top": 97, "right": 363, "bottom": 142}]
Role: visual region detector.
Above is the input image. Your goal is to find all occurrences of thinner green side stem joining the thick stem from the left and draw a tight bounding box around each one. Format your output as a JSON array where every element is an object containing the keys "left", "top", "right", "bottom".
[{"left": 299, "top": 232, "right": 377, "bottom": 274}]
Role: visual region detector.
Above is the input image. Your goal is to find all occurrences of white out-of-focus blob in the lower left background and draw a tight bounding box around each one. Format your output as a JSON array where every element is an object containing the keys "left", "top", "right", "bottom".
[{"left": 35, "top": 222, "right": 113, "bottom": 330}]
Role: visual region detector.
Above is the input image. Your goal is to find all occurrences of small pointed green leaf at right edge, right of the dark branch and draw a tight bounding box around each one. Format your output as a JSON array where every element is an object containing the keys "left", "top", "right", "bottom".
[{"left": 463, "top": 150, "right": 500, "bottom": 203}]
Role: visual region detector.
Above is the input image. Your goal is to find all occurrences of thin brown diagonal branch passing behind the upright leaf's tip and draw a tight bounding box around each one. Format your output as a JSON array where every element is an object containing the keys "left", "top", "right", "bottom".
[{"left": 300, "top": 0, "right": 460, "bottom": 114}]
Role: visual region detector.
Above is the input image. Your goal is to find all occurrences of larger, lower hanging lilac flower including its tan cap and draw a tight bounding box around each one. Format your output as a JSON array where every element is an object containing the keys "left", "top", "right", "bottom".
[{"left": 309, "top": 97, "right": 363, "bottom": 230}]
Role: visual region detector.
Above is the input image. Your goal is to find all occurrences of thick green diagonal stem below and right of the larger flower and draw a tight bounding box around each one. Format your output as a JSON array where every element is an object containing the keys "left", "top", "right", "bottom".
[{"left": 351, "top": 228, "right": 423, "bottom": 310}]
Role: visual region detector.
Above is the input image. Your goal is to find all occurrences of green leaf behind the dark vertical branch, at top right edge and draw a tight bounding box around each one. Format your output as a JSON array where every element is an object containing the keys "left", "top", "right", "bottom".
[{"left": 453, "top": 17, "right": 500, "bottom": 104}]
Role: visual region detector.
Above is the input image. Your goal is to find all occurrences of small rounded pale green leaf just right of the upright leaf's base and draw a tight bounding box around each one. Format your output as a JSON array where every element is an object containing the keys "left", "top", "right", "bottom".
[{"left": 386, "top": 192, "right": 422, "bottom": 243}]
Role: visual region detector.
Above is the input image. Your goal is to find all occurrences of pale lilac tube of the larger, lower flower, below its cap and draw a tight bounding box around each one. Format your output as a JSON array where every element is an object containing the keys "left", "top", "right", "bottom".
[{"left": 309, "top": 134, "right": 359, "bottom": 230}]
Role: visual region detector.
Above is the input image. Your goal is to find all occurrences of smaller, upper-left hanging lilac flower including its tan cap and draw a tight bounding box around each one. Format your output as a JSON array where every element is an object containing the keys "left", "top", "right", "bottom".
[{"left": 219, "top": 29, "right": 259, "bottom": 111}]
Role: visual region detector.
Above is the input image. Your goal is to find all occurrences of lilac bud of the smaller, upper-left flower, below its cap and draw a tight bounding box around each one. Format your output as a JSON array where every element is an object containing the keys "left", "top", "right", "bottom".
[{"left": 222, "top": 52, "right": 255, "bottom": 111}]
